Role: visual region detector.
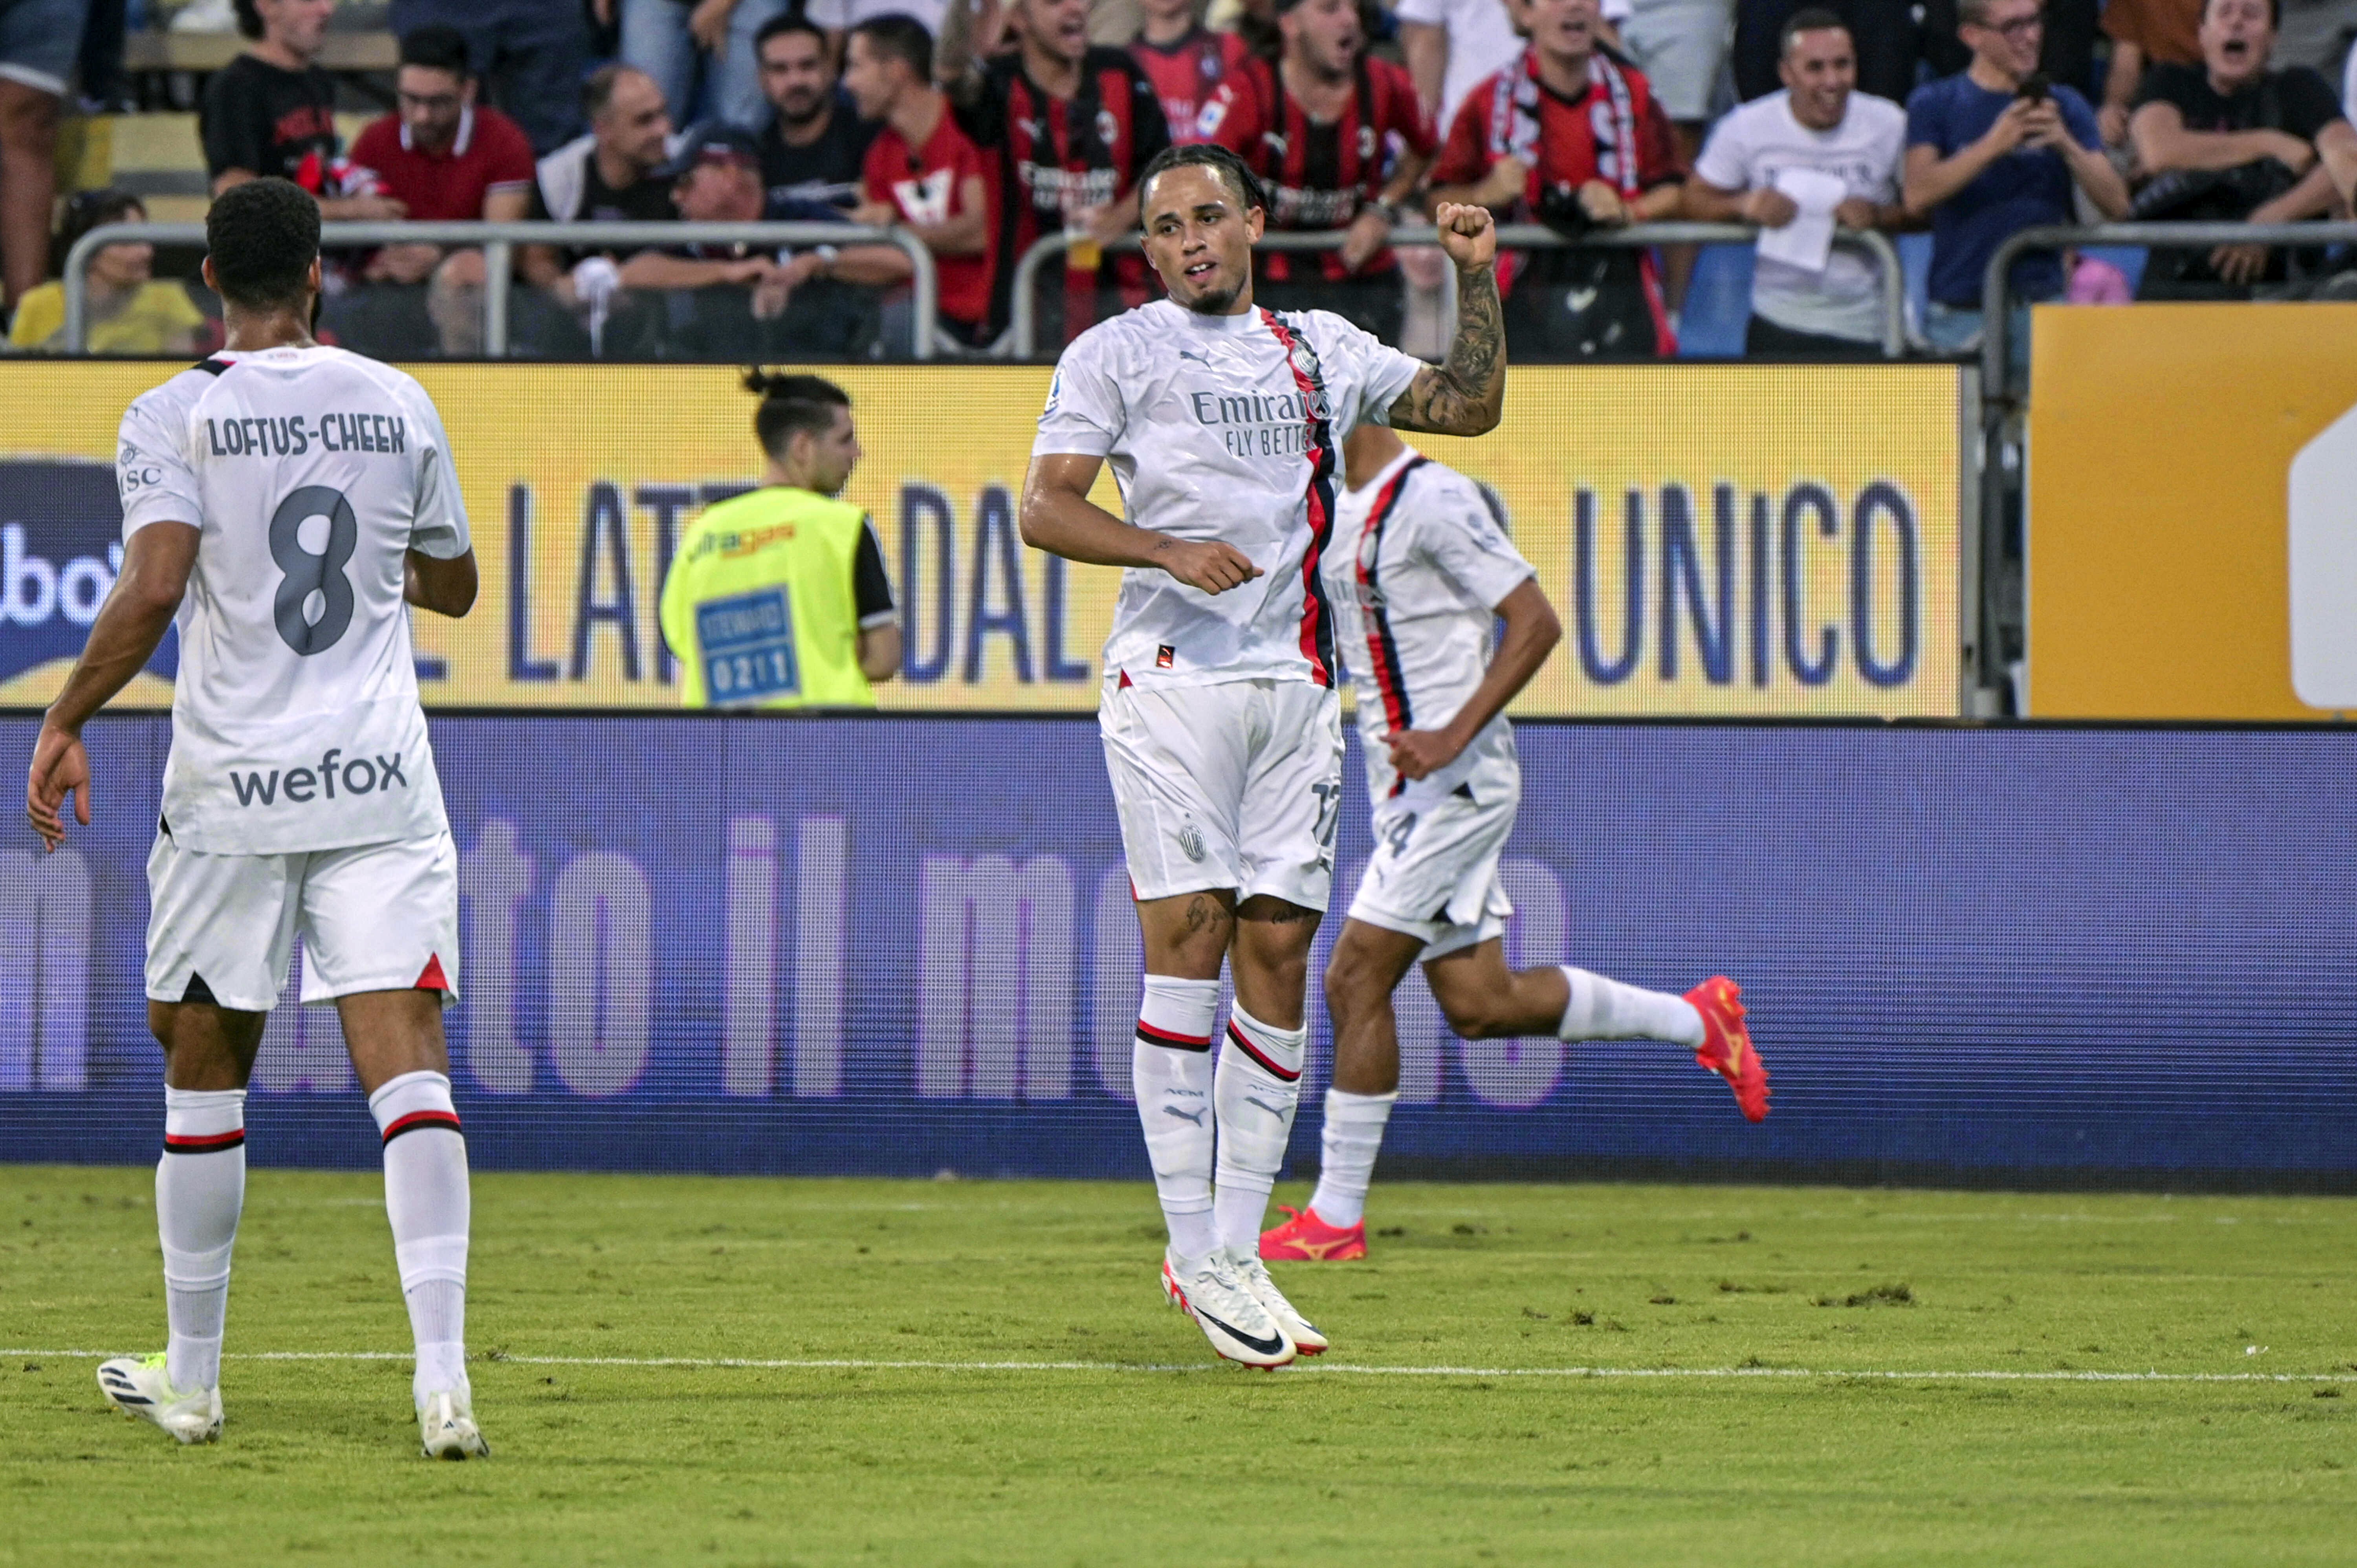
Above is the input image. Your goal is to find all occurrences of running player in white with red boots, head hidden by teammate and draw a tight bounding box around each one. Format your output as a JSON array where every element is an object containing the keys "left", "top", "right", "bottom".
[{"left": 1261, "top": 429, "right": 1768, "bottom": 1262}]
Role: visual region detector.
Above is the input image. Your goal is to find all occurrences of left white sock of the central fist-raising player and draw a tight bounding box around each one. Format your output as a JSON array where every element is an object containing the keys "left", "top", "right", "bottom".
[{"left": 1129, "top": 974, "right": 1219, "bottom": 1264}]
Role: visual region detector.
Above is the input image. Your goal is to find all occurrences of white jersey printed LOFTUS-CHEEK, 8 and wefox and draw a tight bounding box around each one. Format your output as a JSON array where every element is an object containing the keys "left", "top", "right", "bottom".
[{"left": 115, "top": 346, "right": 469, "bottom": 854}]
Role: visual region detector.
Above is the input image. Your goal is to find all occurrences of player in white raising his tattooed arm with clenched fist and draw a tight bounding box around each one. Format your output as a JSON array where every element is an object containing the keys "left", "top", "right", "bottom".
[{"left": 1023, "top": 146, "right": 1506, "bottom": 1368}]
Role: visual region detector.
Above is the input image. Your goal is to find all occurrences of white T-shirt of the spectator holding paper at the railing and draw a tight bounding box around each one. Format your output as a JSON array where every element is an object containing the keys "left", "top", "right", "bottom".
[{"left": 1695, "top": 92, "right": 1907, "bottom": 342}]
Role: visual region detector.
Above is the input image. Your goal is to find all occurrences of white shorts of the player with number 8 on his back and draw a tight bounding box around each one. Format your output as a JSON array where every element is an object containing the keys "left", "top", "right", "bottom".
[{"left": 146, "top": 830, "right": 457, "bottom": 1011}]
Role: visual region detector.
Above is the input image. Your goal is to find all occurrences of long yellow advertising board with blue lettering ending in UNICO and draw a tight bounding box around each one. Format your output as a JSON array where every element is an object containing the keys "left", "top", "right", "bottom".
[{"left": 0, "top": 363, "right": 1961, "bottom": 717}]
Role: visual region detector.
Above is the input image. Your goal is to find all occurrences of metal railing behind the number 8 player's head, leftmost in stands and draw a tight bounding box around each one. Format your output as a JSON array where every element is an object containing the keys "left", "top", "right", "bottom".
[{"left": 64, "top": 222, "right": 940, "bottom": 358}]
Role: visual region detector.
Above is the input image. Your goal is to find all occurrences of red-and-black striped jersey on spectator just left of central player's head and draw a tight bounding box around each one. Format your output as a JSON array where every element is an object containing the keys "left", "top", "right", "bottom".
[{"left": 957, "top": 47, "right": 1171, "bottom": 337}]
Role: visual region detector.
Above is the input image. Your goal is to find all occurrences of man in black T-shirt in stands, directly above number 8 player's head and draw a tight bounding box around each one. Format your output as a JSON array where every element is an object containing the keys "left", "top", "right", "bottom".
[{"left": 196, "top": 0, "right": 405, "bottom": 222}]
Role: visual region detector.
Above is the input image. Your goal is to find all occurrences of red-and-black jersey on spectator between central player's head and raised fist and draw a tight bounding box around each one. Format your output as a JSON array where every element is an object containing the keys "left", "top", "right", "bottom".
[{"left": 1200, "top": 57, "right": 1433, "bottom": 280}]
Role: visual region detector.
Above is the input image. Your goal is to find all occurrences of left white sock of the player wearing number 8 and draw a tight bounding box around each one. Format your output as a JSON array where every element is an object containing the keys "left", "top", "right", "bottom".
[{"left": 156, "top": 1089, "right": 245, "bottom": 1394}]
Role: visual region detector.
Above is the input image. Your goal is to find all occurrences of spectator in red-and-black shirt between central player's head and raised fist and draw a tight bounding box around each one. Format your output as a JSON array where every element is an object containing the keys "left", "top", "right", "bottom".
[{"left": 1202, "top": 0, "right": 1433, "bottom": 344}]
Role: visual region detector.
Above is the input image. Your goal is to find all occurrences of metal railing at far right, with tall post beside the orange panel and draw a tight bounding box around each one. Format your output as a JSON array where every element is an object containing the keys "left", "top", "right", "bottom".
[{"left": 1980, "top": 222, "right": 2357, "bottom": 707}]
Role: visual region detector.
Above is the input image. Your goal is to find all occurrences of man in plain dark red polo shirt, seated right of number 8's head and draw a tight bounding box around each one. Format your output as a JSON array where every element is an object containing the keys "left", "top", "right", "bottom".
[{"left": 332, "top": 26, "right": 533, "bottom": 354}]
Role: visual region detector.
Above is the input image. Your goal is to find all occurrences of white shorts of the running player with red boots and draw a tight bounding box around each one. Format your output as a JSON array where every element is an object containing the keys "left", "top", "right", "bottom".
[{"left": 1351, "top": 738, "right": 1523, "bottom": 964}]
